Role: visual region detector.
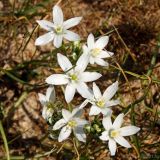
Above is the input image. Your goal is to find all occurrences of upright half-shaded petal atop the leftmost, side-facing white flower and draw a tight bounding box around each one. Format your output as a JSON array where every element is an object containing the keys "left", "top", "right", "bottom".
[{"left": 46, "top": 86, "right": 56, "bottom": 102}]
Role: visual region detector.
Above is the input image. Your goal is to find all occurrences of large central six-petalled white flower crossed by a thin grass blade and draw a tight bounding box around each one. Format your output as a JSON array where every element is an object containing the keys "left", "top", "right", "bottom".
[{"left": 46, "top": 53, "right": 101, "bottom": 103}]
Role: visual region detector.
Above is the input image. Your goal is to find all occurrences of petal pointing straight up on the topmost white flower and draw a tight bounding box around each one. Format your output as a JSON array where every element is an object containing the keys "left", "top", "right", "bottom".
[{"left": 53, "top": 5, "right": 63, "bottom": 25}]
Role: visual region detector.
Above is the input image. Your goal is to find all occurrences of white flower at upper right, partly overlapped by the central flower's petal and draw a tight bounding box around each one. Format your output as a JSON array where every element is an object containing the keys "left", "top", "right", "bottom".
[{"left": 83, "top": 34, "right": 114, "bottom": 66}]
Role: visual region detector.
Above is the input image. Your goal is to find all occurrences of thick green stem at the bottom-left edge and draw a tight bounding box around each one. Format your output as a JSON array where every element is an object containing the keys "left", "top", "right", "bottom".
[{"left": 0, "top": 121, "right": 10, "bottom": 160}]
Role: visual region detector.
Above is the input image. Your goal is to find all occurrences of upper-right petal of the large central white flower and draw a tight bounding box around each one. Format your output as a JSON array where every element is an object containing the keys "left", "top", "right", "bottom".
[{"left": 75, "top": 54, "right": 89, "bottom": 72}]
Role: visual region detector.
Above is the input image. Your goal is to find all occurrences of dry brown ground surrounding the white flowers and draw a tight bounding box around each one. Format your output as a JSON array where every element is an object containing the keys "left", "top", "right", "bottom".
[{"left": 0, "top": 0, "right": 160, "bottom": 160}]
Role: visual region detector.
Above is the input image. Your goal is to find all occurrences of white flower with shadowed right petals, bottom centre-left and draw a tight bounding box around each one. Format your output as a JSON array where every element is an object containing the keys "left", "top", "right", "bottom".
[{"left": 53, "top": 108, "right": 88, "bottom": 142}]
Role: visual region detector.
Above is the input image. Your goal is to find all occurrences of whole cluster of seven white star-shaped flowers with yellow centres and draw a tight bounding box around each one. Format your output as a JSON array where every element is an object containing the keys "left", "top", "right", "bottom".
[{"left": 35, "top": 5, "right": 140, "bottom": 155}]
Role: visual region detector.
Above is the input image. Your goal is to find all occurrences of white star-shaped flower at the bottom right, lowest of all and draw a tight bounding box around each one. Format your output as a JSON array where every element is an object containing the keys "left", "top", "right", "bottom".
[{"left": 100, "top": 113, "right": 140, "bottom": 156}]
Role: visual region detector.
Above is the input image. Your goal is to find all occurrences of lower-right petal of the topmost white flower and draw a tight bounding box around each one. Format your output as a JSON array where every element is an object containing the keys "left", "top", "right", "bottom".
[{"left": 64, "top": 30, "right": 80, "bottom": 41}]
